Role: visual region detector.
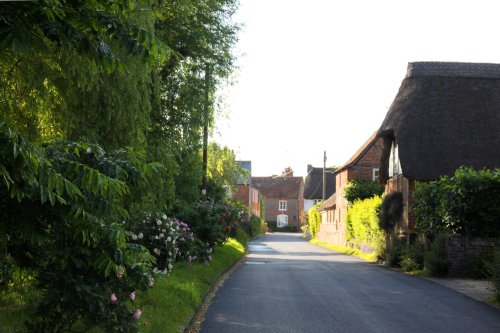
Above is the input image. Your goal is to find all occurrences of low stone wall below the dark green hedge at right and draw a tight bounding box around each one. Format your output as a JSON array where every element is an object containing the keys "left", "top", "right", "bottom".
[{"left": 446, "top": 236, "right": 500, "bottom": 277}]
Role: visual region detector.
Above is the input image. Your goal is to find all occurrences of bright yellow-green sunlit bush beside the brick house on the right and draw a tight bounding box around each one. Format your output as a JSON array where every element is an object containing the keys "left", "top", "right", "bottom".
[{"left": 346, "top": 196, "right": 385, "bottom": 257}]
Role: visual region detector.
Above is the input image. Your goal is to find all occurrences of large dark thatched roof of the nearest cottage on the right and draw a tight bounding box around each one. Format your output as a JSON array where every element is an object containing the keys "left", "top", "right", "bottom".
[{"left": 377, "top": 62, "right": 500, "bottom": 181}]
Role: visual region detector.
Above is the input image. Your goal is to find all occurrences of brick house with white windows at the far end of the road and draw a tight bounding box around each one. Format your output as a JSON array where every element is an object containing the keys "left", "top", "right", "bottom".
[{"left": 252, "top": 172, "right": 304, "bottom": 229}]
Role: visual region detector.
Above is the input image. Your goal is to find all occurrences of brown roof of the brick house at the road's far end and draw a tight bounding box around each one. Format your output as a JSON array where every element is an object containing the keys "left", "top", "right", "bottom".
[{"left": 252, "top": 176, "right": 304, "bottom": 199}]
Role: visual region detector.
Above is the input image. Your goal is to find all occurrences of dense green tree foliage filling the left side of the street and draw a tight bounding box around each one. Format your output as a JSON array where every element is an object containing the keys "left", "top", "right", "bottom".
[{"left": 0, "top": 0, "right": 242, "bottom": 332}]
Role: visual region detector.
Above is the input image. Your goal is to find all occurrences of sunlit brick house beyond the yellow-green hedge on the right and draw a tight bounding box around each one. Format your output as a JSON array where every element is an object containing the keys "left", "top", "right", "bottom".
[{"left": 318, "top": 133, "right": 383, "bottom": 246}]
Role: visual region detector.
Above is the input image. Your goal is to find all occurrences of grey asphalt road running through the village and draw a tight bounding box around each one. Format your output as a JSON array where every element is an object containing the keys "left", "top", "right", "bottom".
[{"left": 200, "top": 233, "right": 500, "bottom": 333}]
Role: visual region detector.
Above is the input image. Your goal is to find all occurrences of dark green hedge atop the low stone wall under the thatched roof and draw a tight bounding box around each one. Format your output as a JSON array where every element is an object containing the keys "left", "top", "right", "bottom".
[{"left": 412, "top": 168, "right": 500, "bottom": 237}]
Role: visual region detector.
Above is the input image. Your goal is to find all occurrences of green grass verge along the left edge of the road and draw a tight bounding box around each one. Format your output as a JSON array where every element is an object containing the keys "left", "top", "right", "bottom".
[{"left": 138, "top": 234, "right": 248, "bottom": 332}]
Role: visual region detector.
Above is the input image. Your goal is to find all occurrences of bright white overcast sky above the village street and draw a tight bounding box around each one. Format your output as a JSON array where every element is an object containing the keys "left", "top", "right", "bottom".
[{"left": 213, "top": 0, "right": 500, "bottom": 176}]
